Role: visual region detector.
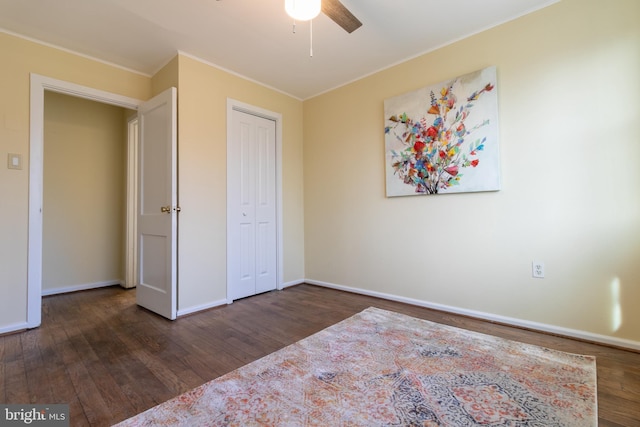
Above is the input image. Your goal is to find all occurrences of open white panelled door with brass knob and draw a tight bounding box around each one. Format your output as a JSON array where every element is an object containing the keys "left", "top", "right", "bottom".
[{"left": 136, "top": 88, "right": 180, "bottom": 320}]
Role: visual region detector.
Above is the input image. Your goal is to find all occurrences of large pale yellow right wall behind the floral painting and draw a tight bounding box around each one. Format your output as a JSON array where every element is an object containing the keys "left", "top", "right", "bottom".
[{"left": 304, "top": 0, "right": 640, "bottom": 342}]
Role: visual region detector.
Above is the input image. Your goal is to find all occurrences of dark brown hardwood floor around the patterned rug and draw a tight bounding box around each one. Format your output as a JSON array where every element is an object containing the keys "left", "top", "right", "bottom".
[{"left": 0, "top": 285, "right": 640, "bottom": 426}]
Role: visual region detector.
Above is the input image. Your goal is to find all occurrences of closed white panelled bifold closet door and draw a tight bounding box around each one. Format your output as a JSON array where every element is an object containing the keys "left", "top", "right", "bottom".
[{"left": 227, "top": 110, "right": 277, "bottom": 300}]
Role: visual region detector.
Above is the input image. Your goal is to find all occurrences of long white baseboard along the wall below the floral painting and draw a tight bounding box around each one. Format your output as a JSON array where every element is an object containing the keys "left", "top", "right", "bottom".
[{"left": 305, "top": 279, "right": 640, "bottom": 351}]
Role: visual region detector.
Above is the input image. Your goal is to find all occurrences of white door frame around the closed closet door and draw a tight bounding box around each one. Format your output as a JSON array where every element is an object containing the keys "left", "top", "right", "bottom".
[{"left": 226, "top": 98, "right": 284, "bottom": 304}]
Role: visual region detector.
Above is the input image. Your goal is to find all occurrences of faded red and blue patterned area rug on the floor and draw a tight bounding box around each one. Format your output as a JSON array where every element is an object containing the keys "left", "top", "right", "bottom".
[{"left": 118, "top": 308, "right": 597, "bottom": 427}]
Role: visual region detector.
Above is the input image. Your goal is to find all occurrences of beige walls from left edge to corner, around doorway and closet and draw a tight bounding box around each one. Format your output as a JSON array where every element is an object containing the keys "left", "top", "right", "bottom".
[{"left": 0, "top": 33, "right": 304, "bottom": 332}]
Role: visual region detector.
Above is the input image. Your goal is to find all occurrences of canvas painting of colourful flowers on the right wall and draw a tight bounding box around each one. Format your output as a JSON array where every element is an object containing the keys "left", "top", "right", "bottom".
[{"left": 384, "top": 67, "right": 500, "bottom": 197}]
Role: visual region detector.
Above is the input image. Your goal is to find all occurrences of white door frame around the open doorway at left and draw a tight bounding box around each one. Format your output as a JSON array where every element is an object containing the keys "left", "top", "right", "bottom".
[{"left": 27, "top": 73, "right": 142, "bottom": 328}]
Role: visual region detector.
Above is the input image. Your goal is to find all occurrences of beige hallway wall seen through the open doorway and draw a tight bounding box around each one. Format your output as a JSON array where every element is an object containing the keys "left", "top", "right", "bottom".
[{"left": 42, "top": 92, "right": 127, "bottom": 292}]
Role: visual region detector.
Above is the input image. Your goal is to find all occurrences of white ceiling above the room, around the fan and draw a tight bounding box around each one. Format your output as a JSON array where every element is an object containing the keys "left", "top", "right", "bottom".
[{"left": 0, "top": 0, "right": 559, "bottom": 99}]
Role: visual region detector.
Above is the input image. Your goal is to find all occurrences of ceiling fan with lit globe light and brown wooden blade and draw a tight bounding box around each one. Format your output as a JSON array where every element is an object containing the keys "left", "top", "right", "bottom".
[{"left": 284, "top": 0, "right": 362, "bottom": 33}]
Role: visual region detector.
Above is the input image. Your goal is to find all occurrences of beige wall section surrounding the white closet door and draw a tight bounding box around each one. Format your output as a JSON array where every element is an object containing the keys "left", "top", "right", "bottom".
[{"left": 178, "top": 55, "right": 304, "bottom": 310}]
